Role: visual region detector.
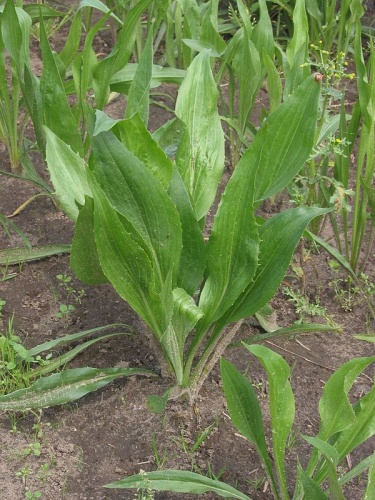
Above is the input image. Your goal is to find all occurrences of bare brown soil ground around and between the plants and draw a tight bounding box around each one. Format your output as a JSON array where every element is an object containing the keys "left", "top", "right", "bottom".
[{"left": 0, "top": 1, "right": 375, "bottom": 500}]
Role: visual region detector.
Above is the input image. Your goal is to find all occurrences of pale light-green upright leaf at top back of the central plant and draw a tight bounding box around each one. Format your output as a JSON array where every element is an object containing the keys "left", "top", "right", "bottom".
[{"left": 176, "top": 51, "right": 224, "bottom": 220}]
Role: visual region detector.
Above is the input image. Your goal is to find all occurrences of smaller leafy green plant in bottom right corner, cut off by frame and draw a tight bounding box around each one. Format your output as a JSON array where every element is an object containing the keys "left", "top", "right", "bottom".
[{"left": 110, "top": 344, "right": 375, "bottom": 500}]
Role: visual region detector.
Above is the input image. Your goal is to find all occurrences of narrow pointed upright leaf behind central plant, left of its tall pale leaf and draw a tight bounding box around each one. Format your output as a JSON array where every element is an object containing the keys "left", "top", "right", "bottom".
[{"left": 125, "top": 29, "right": 154, "bottom": 128}]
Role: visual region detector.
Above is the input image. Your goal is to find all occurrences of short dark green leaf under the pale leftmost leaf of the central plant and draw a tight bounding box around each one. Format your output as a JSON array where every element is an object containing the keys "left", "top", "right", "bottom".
[{"left": 70, "top": 196, "right": 108, "bottom": 285}]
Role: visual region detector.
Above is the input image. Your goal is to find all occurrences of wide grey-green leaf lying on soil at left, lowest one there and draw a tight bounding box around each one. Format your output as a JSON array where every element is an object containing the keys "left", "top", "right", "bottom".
[{"left": 0, "top": 367, "right": 153, "bottom": 411}]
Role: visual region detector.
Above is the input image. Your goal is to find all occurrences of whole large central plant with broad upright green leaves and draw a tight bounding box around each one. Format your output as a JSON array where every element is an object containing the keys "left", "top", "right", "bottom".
[{"left": 45, "top": 50, "right": 326, "bottom": 398}]
